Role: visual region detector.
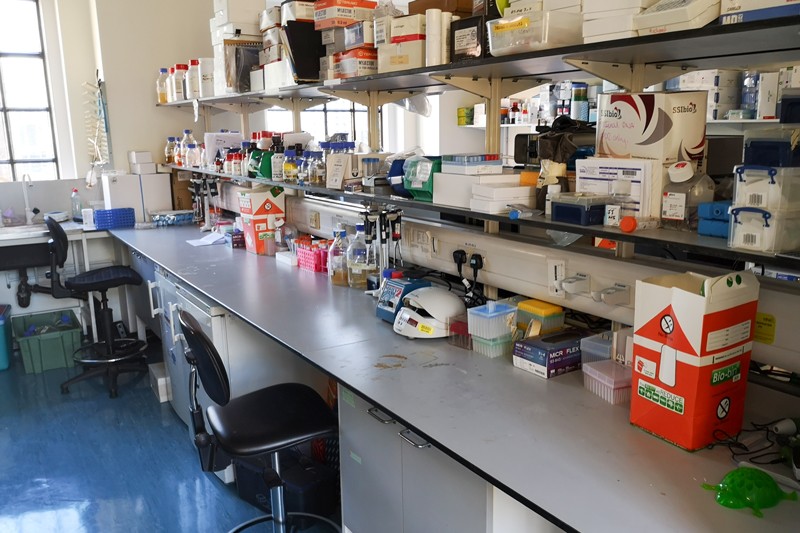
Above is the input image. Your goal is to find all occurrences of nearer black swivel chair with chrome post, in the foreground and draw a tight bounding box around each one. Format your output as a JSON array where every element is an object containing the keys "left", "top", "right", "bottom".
[{"left": 178, "top": 311, "right": 341, "bottom": 533}]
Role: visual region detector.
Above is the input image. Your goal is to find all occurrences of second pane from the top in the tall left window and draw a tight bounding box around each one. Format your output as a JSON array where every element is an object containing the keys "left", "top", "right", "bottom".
[{"left": 0, "top": 57, "right": 47, "bottom": 109}]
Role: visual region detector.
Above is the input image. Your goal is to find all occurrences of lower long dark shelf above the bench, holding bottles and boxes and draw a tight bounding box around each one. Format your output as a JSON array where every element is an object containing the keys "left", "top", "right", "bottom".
[{"left": 172, "top": 166, "right": 800, "bottom": 270}]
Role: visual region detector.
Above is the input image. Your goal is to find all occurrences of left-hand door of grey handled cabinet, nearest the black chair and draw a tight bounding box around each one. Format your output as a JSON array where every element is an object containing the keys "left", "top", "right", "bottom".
[{"left": 339, "top": 385, "right": 404, "bottom": 533}]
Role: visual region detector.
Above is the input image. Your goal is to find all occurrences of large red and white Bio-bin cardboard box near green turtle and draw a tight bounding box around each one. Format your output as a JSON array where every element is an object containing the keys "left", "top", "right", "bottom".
[{"left": 630, "top": 272, "right": 759, "bottom": 450}]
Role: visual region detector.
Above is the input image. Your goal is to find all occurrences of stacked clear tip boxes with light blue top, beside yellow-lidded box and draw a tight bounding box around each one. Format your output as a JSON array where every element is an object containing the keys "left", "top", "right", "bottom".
[{"left": 467, "top": 302, "right": 517, "bottom": 357}]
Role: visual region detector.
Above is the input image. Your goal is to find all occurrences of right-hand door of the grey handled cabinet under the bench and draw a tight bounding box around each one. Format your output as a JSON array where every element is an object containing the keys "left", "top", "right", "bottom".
[{"left": 401, "top": 430, "right": 491, "bottom": 533}]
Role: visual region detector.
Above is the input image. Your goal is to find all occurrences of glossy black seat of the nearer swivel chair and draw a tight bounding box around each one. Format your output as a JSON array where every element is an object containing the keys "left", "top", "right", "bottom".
[{"left": 206, "top": 383, "right": 337, "bottom": 456}]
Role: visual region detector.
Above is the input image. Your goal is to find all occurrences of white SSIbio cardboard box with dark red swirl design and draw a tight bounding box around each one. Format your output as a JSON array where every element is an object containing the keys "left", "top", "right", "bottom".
[{"left": 596, "top": 91, "right": 708, "bottom": 164}]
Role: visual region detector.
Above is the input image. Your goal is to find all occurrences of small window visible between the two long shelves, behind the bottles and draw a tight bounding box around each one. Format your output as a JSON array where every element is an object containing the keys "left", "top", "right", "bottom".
[{"left": 266, "top": 100, "right": 376, "bottom": 144}]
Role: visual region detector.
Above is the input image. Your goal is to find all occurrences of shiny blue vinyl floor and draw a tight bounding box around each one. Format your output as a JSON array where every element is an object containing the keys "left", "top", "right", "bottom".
[{"left": 0, "top": 338, "right": 338, "bottom": 533}]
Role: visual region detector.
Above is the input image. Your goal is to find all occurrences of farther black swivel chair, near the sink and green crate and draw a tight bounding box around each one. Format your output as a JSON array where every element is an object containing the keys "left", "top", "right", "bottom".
[{"left": 31, "top": 217, "right": 148, "bottom": 398}]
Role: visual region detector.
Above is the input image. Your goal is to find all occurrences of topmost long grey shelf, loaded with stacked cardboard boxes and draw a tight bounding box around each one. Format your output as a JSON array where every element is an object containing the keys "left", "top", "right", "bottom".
[{"left": 158, "top": 17, "right": 800, "bottom": 107}]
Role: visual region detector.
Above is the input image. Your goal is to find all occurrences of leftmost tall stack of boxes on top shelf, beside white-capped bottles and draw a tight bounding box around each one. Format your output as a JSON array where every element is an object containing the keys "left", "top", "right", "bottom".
[{"left": 209, "top": 0, "right": 264, "bottom": 96}]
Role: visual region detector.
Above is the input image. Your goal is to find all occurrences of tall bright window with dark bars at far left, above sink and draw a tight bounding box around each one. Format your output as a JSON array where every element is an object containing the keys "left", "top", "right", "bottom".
[{"left": 0, "top": 0, "right": 59, "bottom": 182}]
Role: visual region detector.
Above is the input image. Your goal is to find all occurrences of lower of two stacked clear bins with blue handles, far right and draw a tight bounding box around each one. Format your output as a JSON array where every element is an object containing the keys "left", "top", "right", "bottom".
[{"left": 728, "top": 207, "right": 800, "bottom": 253}]
